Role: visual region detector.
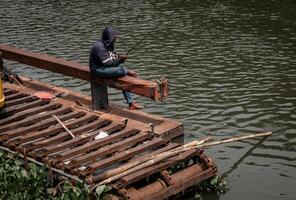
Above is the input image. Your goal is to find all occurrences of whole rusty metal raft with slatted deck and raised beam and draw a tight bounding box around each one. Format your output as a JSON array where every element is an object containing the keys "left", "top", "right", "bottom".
[{"left": 0, "top": 45, "right": 217, "bottom": 200}]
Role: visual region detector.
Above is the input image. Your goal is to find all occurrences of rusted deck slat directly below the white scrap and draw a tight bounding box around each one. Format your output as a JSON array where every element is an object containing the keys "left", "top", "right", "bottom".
[{"left": 53, "top": 129, "right": 140, "bottom": 163}]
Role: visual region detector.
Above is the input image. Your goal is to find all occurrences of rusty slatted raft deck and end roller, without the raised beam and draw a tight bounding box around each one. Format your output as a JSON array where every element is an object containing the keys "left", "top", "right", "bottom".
[{"left": 0, "top": 79, "right": 217, "bottom": 199}]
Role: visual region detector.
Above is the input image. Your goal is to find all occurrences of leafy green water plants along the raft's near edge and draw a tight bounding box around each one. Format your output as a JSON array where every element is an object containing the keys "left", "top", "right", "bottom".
[{"left": 0, "top": 149, "right": 228, "bottom": 200}]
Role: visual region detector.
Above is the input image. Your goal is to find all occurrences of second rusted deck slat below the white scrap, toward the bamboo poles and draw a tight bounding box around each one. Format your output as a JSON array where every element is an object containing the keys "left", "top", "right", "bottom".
[{"left": 66, "top": 133, "right": 153, "bottom": 169}]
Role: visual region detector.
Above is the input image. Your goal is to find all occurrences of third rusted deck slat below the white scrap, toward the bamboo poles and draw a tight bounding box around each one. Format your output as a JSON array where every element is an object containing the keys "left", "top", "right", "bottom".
[{"left": 77, "top": 138, "right": 167, "bottom": 177}]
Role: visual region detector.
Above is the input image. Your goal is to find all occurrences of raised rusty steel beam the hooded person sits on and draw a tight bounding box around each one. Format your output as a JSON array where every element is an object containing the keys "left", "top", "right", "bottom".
[{"left": 0, "top": 44, "right": 168, "bottom": 100}]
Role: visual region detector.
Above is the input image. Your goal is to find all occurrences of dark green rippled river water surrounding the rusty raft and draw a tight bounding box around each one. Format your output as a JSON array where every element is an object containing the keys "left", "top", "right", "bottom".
[{"left": 0, "top": 0, "right": 296, "bottom": 200}]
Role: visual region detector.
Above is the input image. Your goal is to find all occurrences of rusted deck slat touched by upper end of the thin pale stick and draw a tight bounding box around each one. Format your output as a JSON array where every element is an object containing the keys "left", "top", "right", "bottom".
[{"left": 0, "top": 104, "right": 66, "bottom": 133}]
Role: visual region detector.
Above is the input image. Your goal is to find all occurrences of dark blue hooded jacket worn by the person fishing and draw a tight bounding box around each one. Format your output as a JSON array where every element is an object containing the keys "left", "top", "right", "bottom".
[{"left": 89, "top": 27, "right": 123, "bottom": 72}]
